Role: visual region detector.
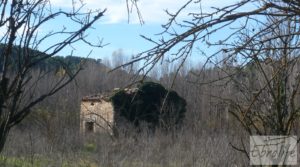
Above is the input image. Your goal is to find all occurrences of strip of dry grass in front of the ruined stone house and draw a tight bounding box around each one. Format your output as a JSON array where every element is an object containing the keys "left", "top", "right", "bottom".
[{"left": 4, "top": 125, "right": 249, "bottom": 167}]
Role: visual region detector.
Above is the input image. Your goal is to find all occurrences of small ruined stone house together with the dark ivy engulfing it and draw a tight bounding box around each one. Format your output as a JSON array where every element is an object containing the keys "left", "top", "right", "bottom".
[{"left": 80, "top": 82, "right": 186, "bottom": 135}]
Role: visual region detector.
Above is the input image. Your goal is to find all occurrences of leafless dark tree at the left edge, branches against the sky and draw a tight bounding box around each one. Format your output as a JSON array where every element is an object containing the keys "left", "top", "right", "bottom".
[{"left": 0, "top": 0, "right": 105, "bottom": 151}]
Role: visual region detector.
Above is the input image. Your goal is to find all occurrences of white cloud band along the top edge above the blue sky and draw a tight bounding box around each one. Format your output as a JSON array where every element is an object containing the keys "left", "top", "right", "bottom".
[{"left": 51, "top": 0, "right": 236, "bottom": 24}]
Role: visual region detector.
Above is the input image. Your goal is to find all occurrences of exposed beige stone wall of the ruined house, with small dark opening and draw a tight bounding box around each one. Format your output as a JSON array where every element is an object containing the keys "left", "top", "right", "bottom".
[{"left": 80, "top": 95, "right": 114, "bottom": 134}]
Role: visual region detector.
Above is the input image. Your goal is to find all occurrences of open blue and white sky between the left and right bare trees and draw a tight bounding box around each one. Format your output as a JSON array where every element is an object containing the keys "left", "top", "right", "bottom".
[{"left": 47, "top": 0, "right": 241, "bottom": 63}]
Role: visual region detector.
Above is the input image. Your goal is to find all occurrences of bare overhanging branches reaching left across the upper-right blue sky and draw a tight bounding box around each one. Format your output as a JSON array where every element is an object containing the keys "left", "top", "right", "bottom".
[{"left": 129, "top": 0, "right": 300, "bottom": 72}]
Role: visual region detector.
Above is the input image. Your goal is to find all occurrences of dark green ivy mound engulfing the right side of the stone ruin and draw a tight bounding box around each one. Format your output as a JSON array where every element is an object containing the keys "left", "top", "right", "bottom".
[{"left": 111, "top": 82, "right": 186, "bottom": 130}]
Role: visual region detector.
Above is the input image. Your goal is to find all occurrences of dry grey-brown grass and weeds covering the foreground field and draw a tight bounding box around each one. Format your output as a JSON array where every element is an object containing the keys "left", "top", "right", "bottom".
[{"left": 0, "top": 132, "right": 248, "bottom": 167}]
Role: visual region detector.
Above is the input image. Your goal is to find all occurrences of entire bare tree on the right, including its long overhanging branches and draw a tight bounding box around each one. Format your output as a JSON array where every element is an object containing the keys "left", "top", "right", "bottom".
[{"left": 120, "top": 0, "right": 300, "bottom": 162}]
